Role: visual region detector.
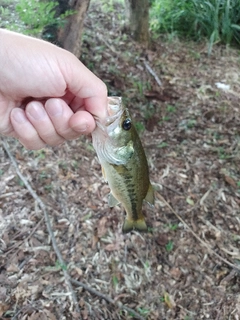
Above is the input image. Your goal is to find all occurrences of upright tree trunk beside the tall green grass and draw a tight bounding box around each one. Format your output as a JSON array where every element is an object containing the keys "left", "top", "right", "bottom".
[{"left": 125, "top": 0, "right": 149, "bottom": 46}]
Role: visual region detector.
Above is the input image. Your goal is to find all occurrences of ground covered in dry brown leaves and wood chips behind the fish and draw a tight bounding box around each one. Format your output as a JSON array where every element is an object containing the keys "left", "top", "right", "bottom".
[{"left": 0, "top": 1, "right": 240, "bottom": 320}]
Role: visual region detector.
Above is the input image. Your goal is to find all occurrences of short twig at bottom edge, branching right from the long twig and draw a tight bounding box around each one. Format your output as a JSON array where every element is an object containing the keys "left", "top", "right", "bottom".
[{"left": 70, "top": 278, "right": 146, "bottom": 320}]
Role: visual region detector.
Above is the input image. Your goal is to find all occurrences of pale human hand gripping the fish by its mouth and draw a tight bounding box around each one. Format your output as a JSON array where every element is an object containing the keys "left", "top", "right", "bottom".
[{"left": 0, "top": 29, "right": 107, "bottom": 150}]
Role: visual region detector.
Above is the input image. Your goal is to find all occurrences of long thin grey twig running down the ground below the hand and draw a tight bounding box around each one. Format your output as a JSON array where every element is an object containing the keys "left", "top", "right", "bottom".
[{"left": 2, "top": 138, "right": 82, "bottom": 319}]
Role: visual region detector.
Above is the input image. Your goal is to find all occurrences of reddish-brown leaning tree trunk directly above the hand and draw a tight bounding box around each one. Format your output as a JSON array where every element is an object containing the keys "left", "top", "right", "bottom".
[{"left": 58, "top": 0, "right": 90, "bottom": 58}]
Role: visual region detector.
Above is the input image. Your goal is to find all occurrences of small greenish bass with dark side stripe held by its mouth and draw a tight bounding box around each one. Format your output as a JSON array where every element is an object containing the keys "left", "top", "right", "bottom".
[{"left": 92, "top": 96, "right": 154, "bottom": 233}]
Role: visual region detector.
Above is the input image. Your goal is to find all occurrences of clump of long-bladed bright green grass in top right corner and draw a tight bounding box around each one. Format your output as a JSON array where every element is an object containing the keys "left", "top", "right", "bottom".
[{"left": 150, "top": 0, "right": 240, "bottom": 54}]
